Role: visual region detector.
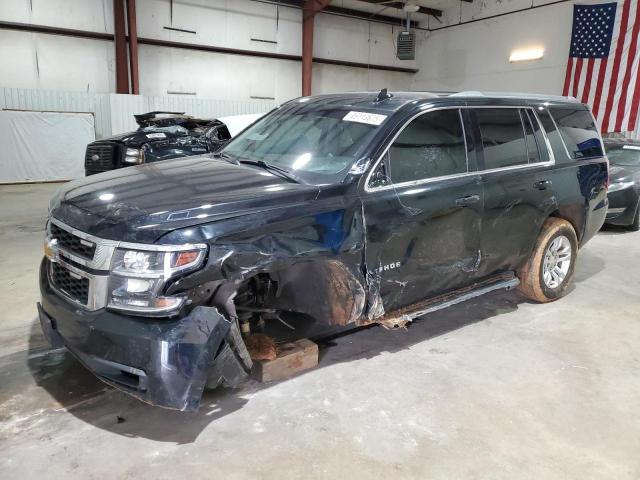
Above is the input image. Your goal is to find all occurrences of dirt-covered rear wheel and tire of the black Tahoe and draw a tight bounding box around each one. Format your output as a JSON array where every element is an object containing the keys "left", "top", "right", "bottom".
[{"left": 518, "top": 217, "right": 578, "bottom": 303}]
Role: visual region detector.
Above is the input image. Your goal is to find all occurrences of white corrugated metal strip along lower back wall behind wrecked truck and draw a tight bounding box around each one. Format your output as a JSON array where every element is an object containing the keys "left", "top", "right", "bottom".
[{"left": 0, "top": 88, "right": 276, "bottom": 139}]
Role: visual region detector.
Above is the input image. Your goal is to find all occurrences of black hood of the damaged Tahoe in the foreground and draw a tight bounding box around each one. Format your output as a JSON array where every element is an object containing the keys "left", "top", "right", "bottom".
[{"left": 50, "top": 156, "right": 319, "bottom": 243}]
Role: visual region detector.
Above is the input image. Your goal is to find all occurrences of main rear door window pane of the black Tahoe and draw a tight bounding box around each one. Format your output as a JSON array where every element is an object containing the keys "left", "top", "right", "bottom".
[{"left": 475, "top": 108, "right": 529, "bottom": 170}]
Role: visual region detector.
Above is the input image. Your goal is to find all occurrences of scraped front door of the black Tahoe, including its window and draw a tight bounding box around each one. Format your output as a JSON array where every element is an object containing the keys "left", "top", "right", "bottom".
[{"left": 363, "top": 108, "right": 483, "bottom": 315}]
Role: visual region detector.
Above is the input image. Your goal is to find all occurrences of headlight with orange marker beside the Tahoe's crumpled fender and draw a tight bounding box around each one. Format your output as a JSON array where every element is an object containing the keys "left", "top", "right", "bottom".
[{"left": 107, "top": 245, "right": 206, "bottom": 315}]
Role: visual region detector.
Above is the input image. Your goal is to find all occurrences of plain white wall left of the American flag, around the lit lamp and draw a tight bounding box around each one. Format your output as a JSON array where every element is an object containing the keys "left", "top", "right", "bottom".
[{"left": 412, "top": 0, "right": 573, "bottom": 95}]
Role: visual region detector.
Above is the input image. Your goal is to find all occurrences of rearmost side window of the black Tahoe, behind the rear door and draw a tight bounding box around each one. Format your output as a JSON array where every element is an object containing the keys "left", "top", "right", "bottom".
[{"left": 549, "top": 107, "right": 603, "bottom": 160}]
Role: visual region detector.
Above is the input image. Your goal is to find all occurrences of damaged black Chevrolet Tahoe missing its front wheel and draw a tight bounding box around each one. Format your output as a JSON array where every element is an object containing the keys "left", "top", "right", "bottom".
[{"left": 39, "top": 90, "right": 608, "bottom": 410}]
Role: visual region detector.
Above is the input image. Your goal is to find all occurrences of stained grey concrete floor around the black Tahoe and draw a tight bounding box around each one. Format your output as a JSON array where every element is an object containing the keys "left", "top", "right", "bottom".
[{"left": 0, "top": 185, "right": 640, "bottom": 480}]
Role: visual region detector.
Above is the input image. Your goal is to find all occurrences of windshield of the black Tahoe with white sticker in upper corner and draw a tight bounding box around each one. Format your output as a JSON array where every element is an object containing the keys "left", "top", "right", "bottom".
[{"left": 223, "top": 105, "right": 386, "bottom": 184}]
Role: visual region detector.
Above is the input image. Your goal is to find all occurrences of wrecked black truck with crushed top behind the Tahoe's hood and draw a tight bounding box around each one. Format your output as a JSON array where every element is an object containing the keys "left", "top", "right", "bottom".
[{"left": 84, "top": 112, "right": 231, "bottom": 176}]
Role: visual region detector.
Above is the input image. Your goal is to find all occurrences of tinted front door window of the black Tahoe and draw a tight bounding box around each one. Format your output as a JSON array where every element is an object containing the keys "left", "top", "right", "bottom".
[{"left": 388, "top": 109, "right": 467, "bottom": 183}]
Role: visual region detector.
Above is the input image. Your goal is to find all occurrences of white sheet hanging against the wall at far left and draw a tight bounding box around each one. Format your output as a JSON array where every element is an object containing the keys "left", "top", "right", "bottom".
[{"left": 0, "top": 110, "right": 95, "bottom": 183}]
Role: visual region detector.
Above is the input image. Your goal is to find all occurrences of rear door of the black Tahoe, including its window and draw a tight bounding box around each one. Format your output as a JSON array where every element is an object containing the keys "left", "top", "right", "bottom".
[{"left": 470, "top": 107, "right": 554, "bottom": 275}]
